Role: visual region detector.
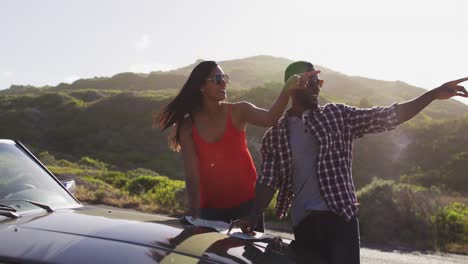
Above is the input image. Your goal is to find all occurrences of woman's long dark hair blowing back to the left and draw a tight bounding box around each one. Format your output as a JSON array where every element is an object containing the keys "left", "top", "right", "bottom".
[{"left": 153, "top": 61, "right": 218, "bottom": 151}]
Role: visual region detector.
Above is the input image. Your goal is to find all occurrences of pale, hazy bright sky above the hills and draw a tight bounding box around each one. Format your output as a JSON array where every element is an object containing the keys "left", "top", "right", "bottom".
[{"left": 0, "top": 0, "right": 468, "bottom": 104}]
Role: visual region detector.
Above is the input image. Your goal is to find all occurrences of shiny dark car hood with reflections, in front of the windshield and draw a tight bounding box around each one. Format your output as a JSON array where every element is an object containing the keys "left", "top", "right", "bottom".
[{"left": 0, "top": 207, "right": 292, "bottom": 263}]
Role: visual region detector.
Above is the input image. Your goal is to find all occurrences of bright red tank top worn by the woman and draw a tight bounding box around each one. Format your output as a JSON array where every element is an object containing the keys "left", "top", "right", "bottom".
[{"left": 192, "top": 105, "right": 257, "bottom": 208}]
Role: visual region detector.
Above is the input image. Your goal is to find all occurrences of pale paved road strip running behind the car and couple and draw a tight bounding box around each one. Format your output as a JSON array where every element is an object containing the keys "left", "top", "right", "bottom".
[{"left": 86, "top": 205, "right": 468, "bottom": 264}]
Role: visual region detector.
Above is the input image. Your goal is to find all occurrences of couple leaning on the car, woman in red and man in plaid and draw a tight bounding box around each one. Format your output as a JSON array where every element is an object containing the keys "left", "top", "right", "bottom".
[{"left": 154, "top": 61, "right": 468, "bottom": 263}]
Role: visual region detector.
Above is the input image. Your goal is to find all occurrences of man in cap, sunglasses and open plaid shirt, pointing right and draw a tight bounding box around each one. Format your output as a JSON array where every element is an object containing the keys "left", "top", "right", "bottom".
[{"left": 243, "top": 61, "right": 468, "bottom": 263}]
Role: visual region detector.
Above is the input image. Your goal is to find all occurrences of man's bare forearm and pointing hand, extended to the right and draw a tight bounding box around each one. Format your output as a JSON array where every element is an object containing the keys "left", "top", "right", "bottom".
[{"left": 397, "top": 78, "right": 468, "bottom": 124}]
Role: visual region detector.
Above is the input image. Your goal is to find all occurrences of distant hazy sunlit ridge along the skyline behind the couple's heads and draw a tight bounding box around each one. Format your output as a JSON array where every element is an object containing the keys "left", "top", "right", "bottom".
[{"left": 0, "top": 55, "right": 468, "bottom": 119}]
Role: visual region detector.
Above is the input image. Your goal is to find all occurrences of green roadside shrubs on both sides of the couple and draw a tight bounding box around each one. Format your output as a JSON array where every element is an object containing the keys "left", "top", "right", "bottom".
[{"left": 38, "top": 152, "right": 468, "bottom": 254}]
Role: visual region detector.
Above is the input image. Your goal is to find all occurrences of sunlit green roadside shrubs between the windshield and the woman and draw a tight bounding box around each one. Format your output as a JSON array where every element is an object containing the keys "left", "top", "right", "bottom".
[{"left": 38, "top": 152, "right": 187, "bottom": 216}]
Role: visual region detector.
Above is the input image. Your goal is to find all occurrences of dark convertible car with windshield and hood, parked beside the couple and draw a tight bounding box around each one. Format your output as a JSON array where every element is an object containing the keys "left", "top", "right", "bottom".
[{"left": 0, "top": 140, "right": 294, "bottom": 263}]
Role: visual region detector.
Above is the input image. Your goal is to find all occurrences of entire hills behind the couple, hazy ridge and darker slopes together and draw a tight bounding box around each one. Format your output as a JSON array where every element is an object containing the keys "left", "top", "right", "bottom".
[{"left": 0, "top": 56, "right": 468, "bottom": 188}]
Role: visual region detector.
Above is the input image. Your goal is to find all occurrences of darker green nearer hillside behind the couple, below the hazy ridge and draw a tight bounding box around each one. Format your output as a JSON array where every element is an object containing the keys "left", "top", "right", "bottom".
[{"left": 0, "top": 84, "right": 468, "bottom": 190}]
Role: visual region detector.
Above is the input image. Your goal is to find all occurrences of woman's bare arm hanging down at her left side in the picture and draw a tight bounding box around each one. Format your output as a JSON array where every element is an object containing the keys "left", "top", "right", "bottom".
[{"left": 180, "top": 118, "right": 200, "bottom": 217}]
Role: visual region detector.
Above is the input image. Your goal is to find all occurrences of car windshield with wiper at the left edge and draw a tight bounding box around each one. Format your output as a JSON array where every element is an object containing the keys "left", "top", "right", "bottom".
[{"left": 0, "top": 140, "right": 80, "bottom": 214}]
